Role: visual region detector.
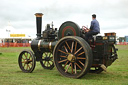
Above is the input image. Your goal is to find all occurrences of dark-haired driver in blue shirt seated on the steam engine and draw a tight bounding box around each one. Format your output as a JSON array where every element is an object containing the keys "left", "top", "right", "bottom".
[{"left": 85, "top": 14, "right": 100, "bottom": 42}]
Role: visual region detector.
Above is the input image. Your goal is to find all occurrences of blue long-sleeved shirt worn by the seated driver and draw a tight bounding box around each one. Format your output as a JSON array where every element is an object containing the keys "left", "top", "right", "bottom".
[{"left": 90, "top": 19, "right": 100, "bottom": 33}]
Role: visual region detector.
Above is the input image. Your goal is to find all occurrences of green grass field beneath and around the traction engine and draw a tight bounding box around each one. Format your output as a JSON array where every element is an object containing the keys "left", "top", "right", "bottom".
[{"left": 0, "top": 45, "right": 128, "bottom": 85}]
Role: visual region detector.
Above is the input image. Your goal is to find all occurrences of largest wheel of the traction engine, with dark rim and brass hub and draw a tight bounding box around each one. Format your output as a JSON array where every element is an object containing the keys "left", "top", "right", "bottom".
[{"left": 53, "top": 36, "right": 92, "bottom": 78}]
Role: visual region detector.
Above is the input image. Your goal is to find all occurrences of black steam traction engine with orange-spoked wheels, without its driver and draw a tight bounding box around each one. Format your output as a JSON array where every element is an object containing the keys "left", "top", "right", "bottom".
[{"left": 18, "top": 13, "right": 117, "bottom": 78}]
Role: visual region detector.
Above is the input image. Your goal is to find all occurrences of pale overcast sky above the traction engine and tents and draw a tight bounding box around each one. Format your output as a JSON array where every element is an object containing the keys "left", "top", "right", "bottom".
[{"left": 0, "top": 0, "right": 128, "bottom": 37}]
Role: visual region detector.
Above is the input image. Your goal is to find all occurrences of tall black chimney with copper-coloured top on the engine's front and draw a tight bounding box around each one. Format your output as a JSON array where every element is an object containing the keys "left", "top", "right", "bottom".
[{"left": 35, "top": 13, "right": 43, "bottom": 39}]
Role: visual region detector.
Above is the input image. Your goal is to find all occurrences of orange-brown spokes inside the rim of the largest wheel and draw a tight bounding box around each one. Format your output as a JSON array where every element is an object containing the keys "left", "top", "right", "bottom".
[{"left": 58, "top": 41, "right": 86, "bottom": 74}]
